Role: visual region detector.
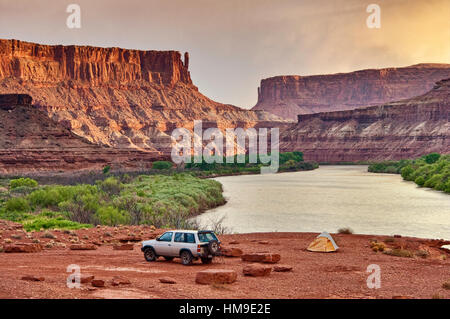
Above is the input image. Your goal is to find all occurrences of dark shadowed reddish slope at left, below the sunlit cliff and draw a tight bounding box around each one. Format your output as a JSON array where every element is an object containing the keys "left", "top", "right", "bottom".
[{"left": 0, "top": 95, "right": 163, "bottom": 174}]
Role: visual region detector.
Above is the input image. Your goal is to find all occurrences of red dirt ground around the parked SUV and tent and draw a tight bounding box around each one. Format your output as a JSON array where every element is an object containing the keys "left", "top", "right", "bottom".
[{"left": 0, "top": 224, "right": 450, "bottom": 299}]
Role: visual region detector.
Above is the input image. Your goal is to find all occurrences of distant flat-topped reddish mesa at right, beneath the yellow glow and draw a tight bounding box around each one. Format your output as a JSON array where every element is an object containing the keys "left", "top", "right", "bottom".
[{"left": 253, "top": 64, "right": 450, "bottom": 119}]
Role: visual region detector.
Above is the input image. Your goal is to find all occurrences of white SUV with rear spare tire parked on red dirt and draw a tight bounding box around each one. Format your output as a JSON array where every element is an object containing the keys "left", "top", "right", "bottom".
[{"left": 141, "top": 230, "right": 220, "bottom": 265}]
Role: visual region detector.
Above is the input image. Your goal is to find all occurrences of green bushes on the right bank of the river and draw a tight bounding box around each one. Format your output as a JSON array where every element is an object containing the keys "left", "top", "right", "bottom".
[{"left": 368, "top": 153, "right": 450, "bottom": 193}]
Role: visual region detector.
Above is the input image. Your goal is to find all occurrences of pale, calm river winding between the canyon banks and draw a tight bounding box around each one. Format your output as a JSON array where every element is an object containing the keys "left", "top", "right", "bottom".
[{"left": 197, "top": 166, "right": 450, "bottom": 240}]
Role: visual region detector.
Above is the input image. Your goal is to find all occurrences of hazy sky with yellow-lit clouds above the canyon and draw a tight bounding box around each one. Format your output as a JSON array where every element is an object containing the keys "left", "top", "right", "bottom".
[{"left": 0, "top": 0, "right": 450, "bottom": 108}]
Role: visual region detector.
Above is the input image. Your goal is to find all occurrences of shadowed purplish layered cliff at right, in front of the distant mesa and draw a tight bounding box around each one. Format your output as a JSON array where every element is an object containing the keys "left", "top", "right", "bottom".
[{"left": 280, "top": 79, "right": 450, "bottom": 162}]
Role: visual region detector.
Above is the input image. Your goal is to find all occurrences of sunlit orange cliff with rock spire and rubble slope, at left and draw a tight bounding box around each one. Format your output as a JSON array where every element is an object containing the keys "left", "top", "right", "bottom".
[{"left": 0, "top": 40, "right": 279, "bottom": 154}]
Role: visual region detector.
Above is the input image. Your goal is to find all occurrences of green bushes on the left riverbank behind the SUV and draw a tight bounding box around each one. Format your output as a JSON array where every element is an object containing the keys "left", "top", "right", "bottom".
[{"left": 0, "top": 174, "right": 225, "bottom": 231}]
